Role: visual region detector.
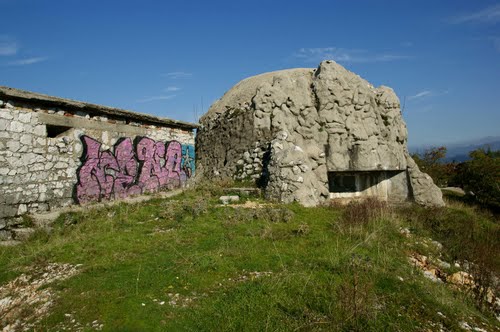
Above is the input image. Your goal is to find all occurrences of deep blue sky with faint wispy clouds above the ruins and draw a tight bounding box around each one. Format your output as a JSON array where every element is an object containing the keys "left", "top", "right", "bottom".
[{"left": 0, "top": 0, "right": 500, "bottom": 145}]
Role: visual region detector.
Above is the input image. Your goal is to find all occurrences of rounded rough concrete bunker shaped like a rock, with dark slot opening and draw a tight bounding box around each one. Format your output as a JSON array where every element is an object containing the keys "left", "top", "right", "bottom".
[{"left": 196, "top": 61, "right": 444, "bottom": 206}]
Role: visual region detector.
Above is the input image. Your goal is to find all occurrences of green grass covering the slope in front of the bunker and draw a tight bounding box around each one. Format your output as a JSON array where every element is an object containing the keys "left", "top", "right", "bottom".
[{"left": 0, "top": 188, "right": 499, "bottom": 331}]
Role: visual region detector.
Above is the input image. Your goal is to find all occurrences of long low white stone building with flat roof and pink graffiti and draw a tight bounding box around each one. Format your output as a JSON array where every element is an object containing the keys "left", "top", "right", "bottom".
[{"left": 0, "top": 87, "right": 198, "bottom": 240}]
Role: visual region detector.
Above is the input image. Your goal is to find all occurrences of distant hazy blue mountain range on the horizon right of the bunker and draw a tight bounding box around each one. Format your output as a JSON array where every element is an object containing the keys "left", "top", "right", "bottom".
[{"left": 409, "top": 136, "right": 500, "bottom": 162}]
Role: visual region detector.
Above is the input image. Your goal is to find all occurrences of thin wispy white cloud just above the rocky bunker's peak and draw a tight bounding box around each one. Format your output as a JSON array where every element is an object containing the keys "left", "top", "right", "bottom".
[{"left": 294, "top": 47, "right": 412, "bottom": 63}]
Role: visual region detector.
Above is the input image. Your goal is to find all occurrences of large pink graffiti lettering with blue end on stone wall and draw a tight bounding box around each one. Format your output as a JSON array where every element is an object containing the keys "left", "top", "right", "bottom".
[{"left": 75, "top": 136, "right": 195, "bottom": 203}]
